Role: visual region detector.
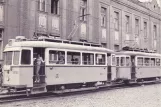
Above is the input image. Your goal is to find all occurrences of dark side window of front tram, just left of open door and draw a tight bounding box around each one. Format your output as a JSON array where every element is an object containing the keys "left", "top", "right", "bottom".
[{"left": 21, "top": 50, "right": 31, "bottom": 64}]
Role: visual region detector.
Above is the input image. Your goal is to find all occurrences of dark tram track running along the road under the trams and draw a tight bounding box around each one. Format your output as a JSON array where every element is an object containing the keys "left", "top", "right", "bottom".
[{"left": 0, "top": 82, "right": 160, "bottom": 104}]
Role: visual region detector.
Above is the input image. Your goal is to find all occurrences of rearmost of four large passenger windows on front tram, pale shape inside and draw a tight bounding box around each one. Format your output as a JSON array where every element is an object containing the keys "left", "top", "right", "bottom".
[{"left": 95, "top": 54, "right": 106, "bottom": 65}]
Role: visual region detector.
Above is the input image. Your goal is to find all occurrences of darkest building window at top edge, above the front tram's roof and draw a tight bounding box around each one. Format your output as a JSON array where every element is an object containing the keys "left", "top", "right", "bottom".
[{"left": 51, "top": 0, "right": 59, "bottom": 14}]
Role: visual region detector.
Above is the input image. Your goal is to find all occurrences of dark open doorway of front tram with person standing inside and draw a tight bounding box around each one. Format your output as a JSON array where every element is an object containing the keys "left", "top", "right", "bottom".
[{"left": 33, "top": 48, "right": 45, "bottom": 84}]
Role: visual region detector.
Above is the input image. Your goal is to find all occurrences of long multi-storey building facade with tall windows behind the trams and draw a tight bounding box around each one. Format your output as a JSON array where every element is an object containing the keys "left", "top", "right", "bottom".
[{"left": 0, "top": 0, "right": 161, "bottom": 60}]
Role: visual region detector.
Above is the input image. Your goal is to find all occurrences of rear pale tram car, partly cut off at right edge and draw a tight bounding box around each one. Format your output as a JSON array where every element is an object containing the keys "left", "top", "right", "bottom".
[{"left": 116, "top": 47, "right": 161, "bottom": 84}]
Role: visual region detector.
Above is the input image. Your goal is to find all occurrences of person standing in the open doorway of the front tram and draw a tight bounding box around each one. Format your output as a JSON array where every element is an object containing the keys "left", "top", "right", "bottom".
[{"left": 35, "top": 54, "right": 44, "bottom": 82}]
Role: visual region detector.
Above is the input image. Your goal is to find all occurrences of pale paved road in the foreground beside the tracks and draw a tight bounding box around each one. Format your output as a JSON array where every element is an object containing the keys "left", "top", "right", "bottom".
[{"left": 0, "top": 84, "right": 161, "bottom": 107}]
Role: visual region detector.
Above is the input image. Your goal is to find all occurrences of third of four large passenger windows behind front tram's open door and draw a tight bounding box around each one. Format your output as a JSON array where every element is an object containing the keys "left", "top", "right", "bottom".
[{"left": 82, "top": 53, "right": 94, "bottom": 65}]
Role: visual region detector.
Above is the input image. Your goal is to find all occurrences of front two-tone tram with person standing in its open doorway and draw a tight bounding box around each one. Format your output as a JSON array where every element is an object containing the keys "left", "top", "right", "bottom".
[{"left": 2, "top": 36, "right": 116, "bottom": 94}]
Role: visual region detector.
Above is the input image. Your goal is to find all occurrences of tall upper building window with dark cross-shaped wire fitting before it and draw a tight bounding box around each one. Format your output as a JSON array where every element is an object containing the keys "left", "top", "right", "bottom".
[{"left": 80, "top": 0, "right": 87, "bottom": 21}]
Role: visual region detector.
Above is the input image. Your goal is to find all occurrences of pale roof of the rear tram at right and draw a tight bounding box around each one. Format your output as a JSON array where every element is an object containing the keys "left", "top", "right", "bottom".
[{"left": 116, "top": 51, "right": 161, "bottom": 57}]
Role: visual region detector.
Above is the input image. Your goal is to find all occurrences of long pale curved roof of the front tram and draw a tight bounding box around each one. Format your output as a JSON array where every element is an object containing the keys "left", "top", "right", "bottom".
[{"left": 4, "top": 41, "right": 114, "bottom": 53}]
